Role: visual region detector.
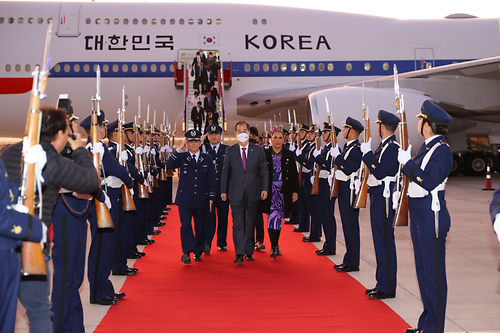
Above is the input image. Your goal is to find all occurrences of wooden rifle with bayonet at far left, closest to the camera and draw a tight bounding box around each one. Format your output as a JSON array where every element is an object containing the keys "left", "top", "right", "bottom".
[{"left": 17, "top": 22, "right": 52, "bottom": 276}]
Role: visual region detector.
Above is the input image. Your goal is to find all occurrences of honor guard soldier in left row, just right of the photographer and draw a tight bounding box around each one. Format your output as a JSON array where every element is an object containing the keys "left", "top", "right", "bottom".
[{"left": 80, "top": 110, "right": 135, "bottom": 305}]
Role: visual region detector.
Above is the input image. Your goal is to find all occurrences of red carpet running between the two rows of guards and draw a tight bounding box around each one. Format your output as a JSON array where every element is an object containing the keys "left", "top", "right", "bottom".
[{"left": 95, "top": 206, "right": 409, "bottom": 333}]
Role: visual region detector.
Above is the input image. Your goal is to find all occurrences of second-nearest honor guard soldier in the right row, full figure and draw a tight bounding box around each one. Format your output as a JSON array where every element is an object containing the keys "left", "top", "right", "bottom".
[{"left": 361, "top": 110, "right": 400, "bottom": 299}]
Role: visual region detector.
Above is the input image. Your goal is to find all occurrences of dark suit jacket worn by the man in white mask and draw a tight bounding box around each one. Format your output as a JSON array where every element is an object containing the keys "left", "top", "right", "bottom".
[{"left": 220, "top": 143, "right": 269, "bottom": 202}]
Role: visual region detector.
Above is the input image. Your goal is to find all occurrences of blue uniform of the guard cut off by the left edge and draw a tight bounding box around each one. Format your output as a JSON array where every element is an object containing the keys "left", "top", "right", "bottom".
[{"left": 0, "top": 161, "right": 42, "bottom": 332}]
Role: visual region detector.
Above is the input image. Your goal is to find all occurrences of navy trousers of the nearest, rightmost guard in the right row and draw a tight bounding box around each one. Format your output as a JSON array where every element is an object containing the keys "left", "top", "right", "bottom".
[{"left": 408, "top": 202, "right": 451, "bottom": 333}]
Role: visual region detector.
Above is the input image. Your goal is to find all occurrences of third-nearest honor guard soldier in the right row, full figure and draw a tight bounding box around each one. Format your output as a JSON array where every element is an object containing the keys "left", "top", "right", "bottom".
[{"left": 330, "top": 117, "right": 364, "bottom": 272}]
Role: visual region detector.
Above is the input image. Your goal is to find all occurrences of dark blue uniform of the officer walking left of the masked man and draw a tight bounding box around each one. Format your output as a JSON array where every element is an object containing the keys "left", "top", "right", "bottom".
[{"left": 203, "top": 143, "right": 229, "bottom": 247}]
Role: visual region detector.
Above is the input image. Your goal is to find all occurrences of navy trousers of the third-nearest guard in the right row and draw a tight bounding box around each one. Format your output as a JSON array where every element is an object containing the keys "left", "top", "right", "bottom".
[{"left": 338, "top": 181, "right": 360, "bottom": 267}]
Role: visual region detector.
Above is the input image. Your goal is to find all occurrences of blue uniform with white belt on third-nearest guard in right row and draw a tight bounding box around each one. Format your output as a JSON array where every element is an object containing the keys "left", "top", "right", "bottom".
[{"left": 334, "top": 139, "right": 362, "bottom": 267}]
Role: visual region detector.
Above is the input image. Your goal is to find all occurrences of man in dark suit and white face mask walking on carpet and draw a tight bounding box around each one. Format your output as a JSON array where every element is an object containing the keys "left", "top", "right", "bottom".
[{"left": 221, "top": 121, "right": 269, "bottom": 264}]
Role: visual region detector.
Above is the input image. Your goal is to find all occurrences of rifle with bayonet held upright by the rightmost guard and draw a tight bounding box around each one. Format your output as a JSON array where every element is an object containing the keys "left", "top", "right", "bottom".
[{"left": 392, "top": 64, "right": 410, "bottom": 227}]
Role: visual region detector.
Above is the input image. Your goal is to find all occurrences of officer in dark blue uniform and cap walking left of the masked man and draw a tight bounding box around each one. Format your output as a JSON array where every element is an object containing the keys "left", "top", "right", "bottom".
[{"left": 202, "top": 125, "right": 229, "bottom": 254}]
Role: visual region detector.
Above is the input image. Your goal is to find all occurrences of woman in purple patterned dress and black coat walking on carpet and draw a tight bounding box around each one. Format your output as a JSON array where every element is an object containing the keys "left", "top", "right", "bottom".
[{"left": 259, "top": 128, "right": 299, "bottom": 259}]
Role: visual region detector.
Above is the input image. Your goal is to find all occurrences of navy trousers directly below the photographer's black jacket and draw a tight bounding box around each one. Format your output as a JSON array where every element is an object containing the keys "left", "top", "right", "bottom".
[{"left": 51, "top": 195, "right": 90, "bottom": 332}]
